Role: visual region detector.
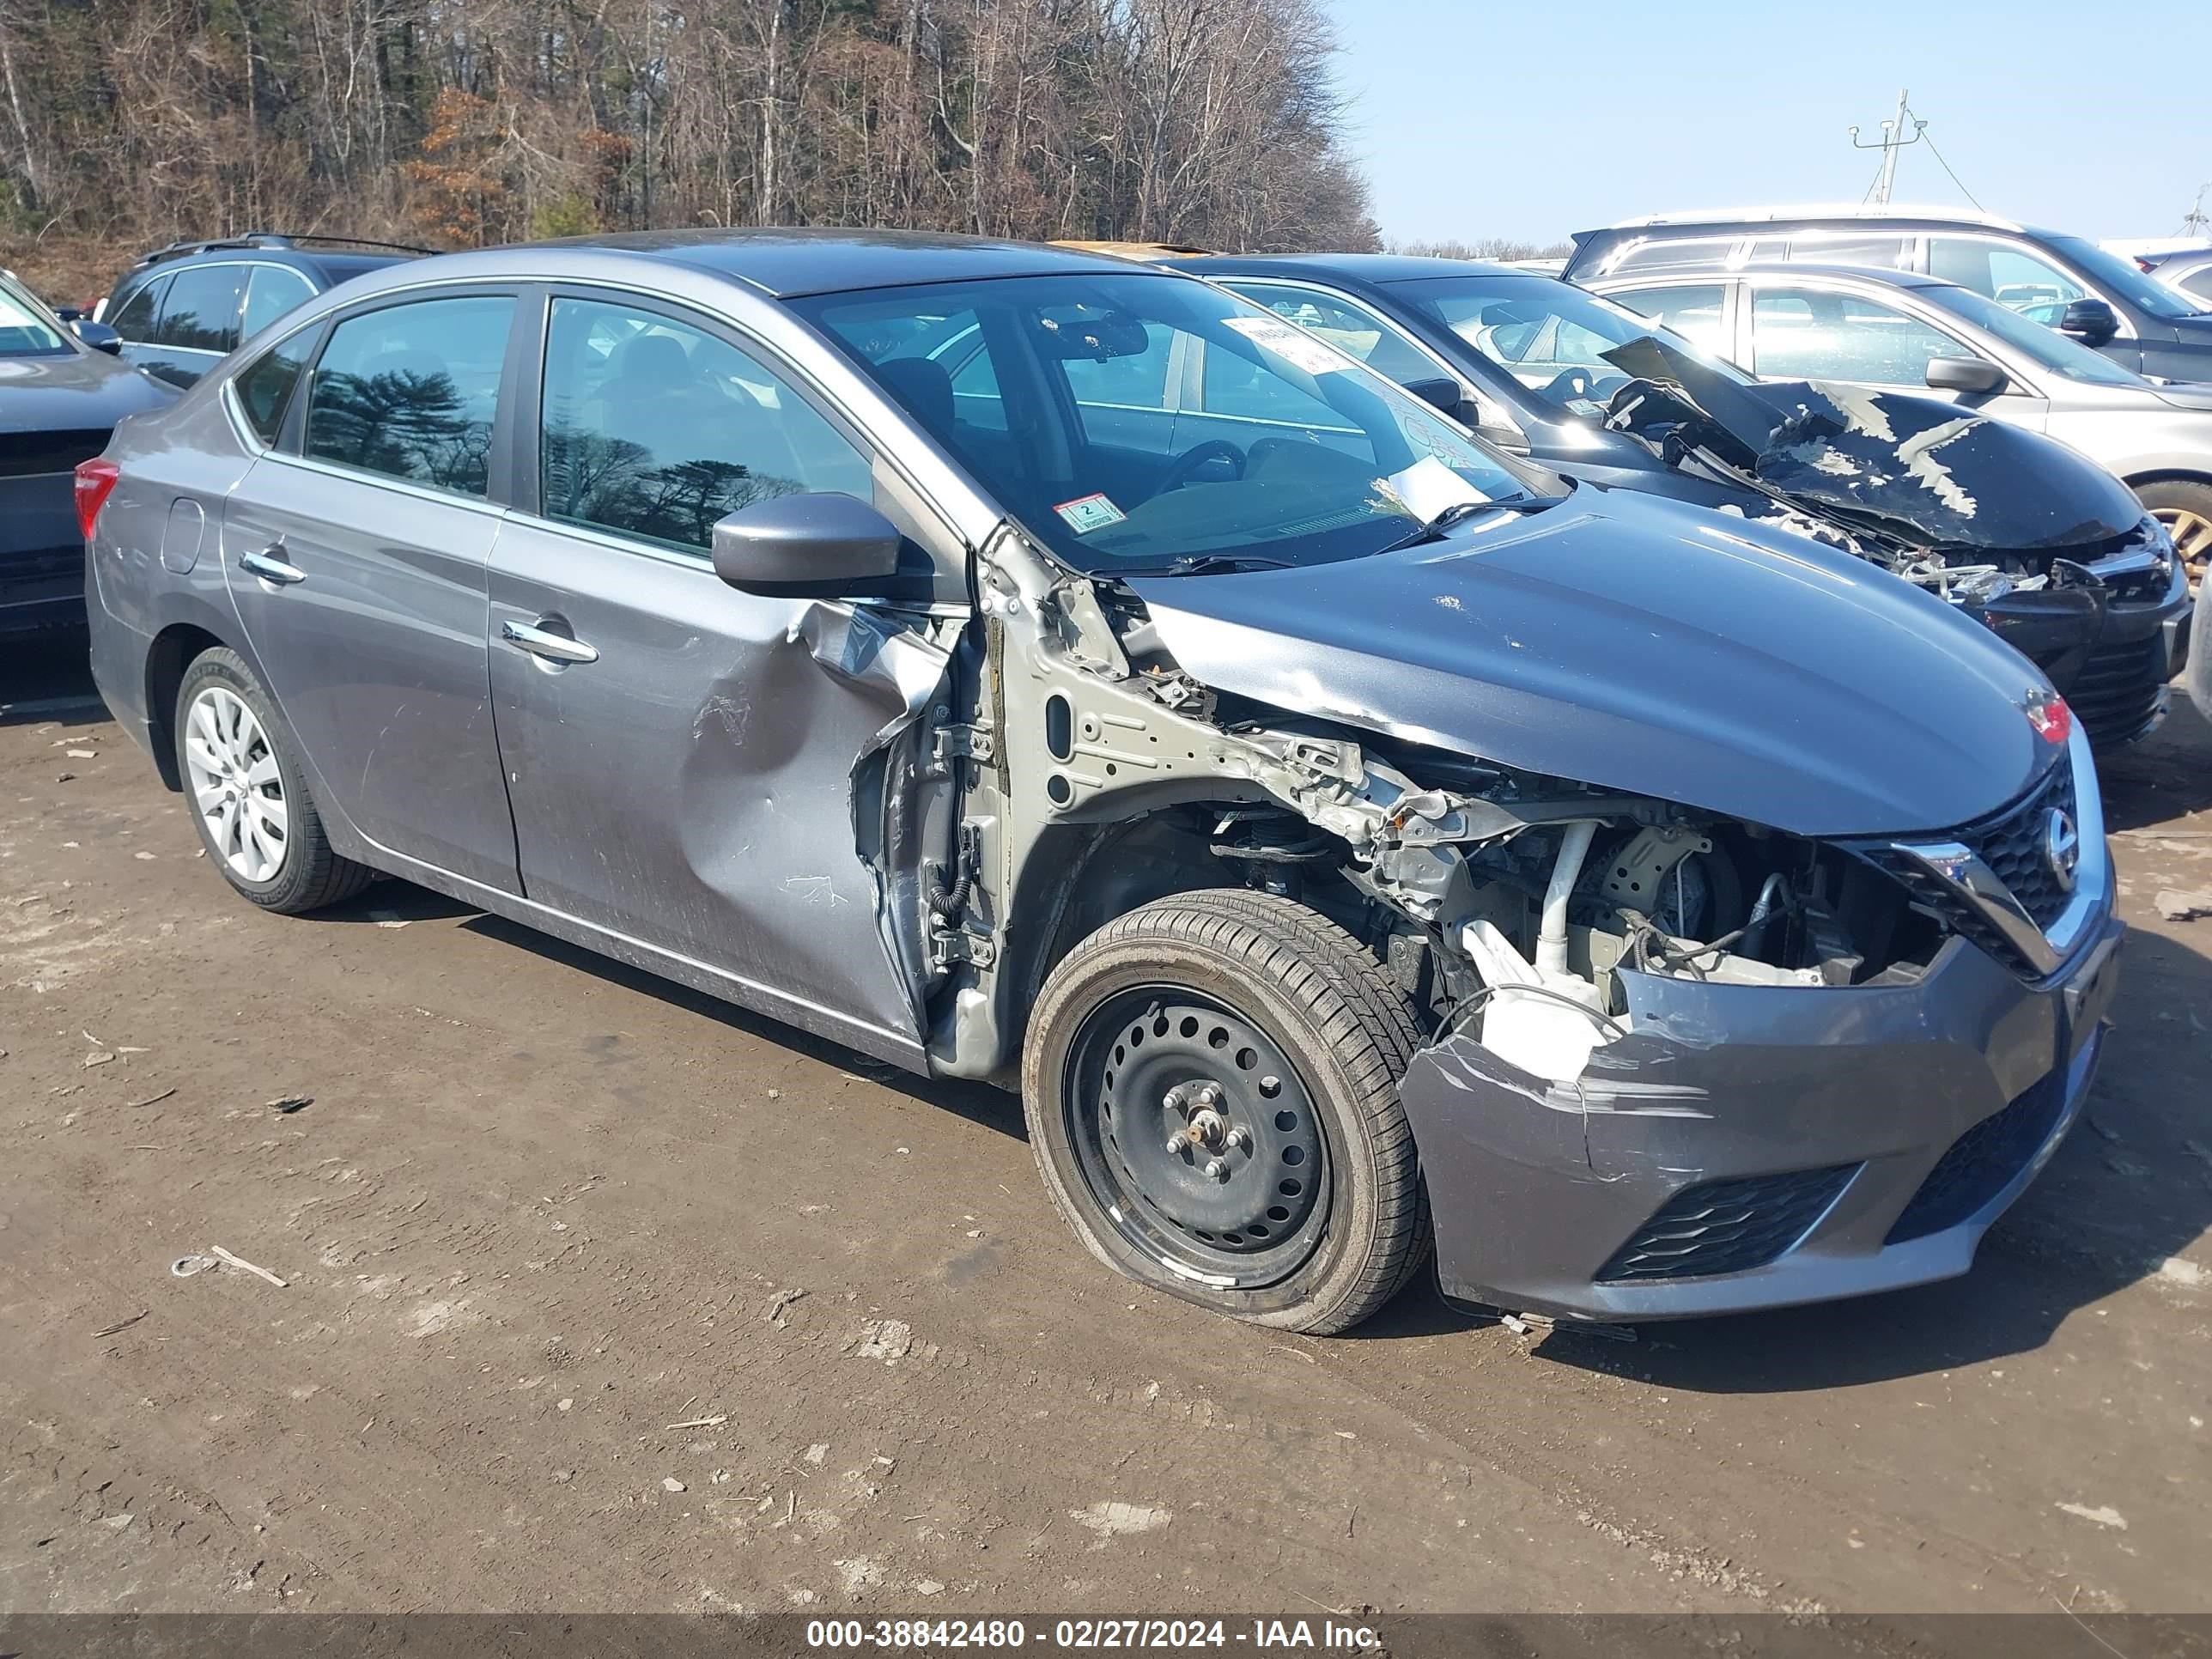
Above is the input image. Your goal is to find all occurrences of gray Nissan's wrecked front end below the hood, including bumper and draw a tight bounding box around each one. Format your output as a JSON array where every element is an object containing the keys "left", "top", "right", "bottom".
[{"left": 931, "top": 513, "right": 2119, "bottom": 1318}]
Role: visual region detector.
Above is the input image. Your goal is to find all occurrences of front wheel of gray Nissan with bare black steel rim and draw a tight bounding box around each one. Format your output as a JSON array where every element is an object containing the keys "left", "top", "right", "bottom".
[{"left": 1022, "top": 890, "right": 1429, "bottom": 1336}]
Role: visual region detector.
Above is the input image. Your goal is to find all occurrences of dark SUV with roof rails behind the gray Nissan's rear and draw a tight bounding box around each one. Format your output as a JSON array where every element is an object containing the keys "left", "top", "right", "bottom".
[{"left": 100, "top": 230, "right": 431, "bottom": 385}]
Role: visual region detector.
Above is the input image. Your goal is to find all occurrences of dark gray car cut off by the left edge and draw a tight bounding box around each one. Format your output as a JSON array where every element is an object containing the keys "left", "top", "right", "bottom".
[{"left": 0, "top": 272, "right": 175, "bottom": 635}]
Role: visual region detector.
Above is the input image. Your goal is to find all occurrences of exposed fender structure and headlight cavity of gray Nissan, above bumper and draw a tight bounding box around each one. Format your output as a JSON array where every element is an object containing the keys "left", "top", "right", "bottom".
[{"left": 929, "top": 526, "right": 1944, "bottom": 1082}]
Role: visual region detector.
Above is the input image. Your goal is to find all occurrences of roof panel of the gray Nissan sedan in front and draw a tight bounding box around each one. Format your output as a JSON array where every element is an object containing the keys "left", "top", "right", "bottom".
[{"left": 515, "top": 228, "right": 1130, "bottom": 299}]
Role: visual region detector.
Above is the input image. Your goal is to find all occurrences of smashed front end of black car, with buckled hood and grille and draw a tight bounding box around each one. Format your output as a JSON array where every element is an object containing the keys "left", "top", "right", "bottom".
[{"left": 1606, "top": 337, "right": 2181, "bottom": 748}]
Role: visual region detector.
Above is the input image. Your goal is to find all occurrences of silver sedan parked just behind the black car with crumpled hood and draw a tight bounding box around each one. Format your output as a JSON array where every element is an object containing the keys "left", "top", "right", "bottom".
[{"left": 1593, "top": 265, "right": 2212, "bottom": 615}]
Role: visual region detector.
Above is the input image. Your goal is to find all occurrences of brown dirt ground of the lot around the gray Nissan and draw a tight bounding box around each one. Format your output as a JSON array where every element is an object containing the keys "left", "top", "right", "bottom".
[{"left": 0, "top": 628, "right": 2212, "bottom": 1613}]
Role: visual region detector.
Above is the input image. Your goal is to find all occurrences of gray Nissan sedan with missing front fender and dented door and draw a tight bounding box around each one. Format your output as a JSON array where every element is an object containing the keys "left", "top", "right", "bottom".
[{"left": 82, "top": 232, "right": 2121, "bottom": 1332}]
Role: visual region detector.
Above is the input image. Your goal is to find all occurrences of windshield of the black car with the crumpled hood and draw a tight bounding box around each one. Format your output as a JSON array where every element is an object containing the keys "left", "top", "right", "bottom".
[{"left": 1391, "top": 274, "right": 1750, "bottom": 420}]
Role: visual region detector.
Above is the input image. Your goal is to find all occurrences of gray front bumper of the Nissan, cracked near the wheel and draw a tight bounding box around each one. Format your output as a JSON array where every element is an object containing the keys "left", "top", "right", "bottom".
[{"left": 1398, "top": 732, "right": 2124, "bottom": 1321}]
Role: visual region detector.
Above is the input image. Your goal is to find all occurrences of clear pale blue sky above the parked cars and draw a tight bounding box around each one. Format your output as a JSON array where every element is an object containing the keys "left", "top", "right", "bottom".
[{"left": 1325, "top": 0, "right": 2212, "bottom": 243}]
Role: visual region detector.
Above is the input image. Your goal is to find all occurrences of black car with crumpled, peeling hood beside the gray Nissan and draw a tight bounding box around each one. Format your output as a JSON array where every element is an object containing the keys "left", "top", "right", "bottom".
[{"left": 1166, "top": 254, "right": 2190, "bottom": 752}]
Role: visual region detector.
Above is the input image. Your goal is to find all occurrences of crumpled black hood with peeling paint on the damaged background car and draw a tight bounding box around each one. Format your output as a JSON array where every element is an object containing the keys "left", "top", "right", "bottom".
[{"left": 1606, "top": 337, "right": 2143, "bottom": 557}]
